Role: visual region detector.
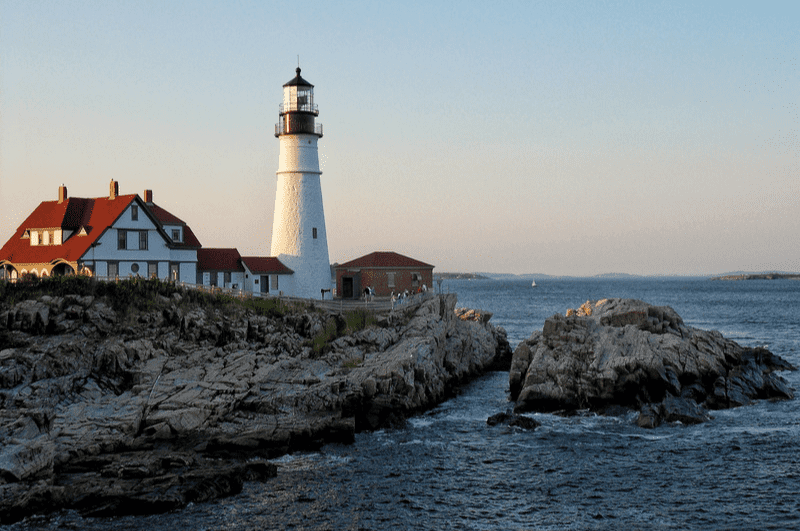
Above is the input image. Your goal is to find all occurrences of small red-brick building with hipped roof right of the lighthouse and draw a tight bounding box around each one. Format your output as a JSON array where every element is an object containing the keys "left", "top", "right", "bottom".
[{"left": 334, "top": 251, "right": 434, "bottom": 299}]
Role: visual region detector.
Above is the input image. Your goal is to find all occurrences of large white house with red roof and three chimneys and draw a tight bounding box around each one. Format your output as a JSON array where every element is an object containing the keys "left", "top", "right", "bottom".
[{"left": 0, "top": 180, "right": 201, "bottom": 283}]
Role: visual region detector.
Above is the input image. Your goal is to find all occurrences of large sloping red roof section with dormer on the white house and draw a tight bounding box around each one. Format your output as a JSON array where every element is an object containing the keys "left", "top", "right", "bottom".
[{"left": 0, "top": 194, "right": 136, "bottom": 264}]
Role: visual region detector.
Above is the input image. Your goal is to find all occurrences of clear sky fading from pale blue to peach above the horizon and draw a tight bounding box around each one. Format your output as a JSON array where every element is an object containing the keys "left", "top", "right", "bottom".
[{"left": 0, "top": 0, "right": 800, "bottom": 276}]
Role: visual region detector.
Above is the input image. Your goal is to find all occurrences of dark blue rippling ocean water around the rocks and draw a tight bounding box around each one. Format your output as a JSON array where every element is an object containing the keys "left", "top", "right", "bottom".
[{"left": 9, "top": 279, "right": 800, "bottom": 531}]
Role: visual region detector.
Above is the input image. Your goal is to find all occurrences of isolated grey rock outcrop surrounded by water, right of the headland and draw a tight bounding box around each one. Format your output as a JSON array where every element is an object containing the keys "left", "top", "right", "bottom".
[{"left": 509, "top": 299, "right": 795, "bottom": 427}]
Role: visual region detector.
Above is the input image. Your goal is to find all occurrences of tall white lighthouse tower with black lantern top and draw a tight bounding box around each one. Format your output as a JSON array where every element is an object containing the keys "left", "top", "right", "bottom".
[{"left": 270, "top": 68, "right": 331, "bottom": 299}]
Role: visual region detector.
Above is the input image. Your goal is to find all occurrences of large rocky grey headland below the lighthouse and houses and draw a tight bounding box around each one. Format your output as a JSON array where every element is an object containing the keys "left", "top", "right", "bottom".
[{"left": 0, "top": 286, "right": 511, "bottom": 523}]
